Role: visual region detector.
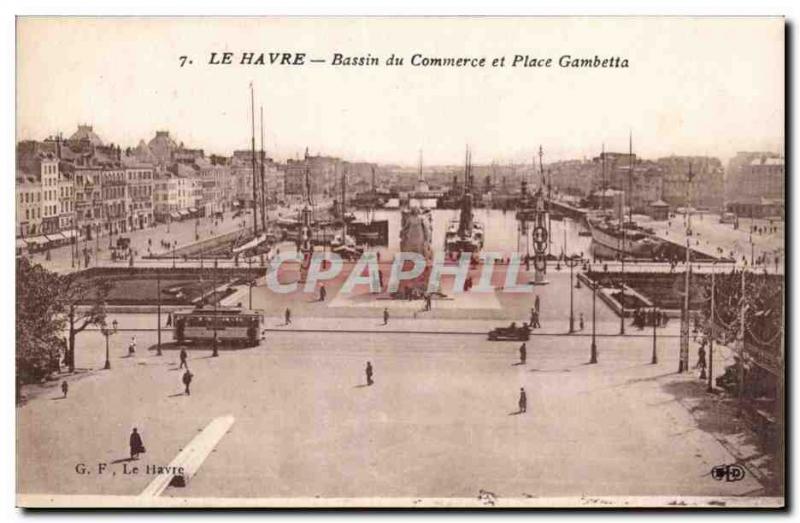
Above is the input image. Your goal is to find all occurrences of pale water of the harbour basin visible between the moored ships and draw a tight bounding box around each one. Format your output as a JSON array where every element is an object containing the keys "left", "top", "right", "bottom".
[{"left": 356, "top": 209, "right": 592, "bottom": 256}]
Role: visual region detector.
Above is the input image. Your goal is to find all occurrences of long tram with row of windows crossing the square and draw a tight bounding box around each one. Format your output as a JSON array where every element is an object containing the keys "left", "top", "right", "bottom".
[{"left": 172, "top": 307, "right": 264, "bottom": 347}]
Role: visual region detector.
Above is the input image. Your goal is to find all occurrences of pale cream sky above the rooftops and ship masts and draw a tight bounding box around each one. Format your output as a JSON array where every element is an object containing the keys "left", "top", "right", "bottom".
[{"left": 17, "top": 17, "right": 785, "bottom": 165}]
